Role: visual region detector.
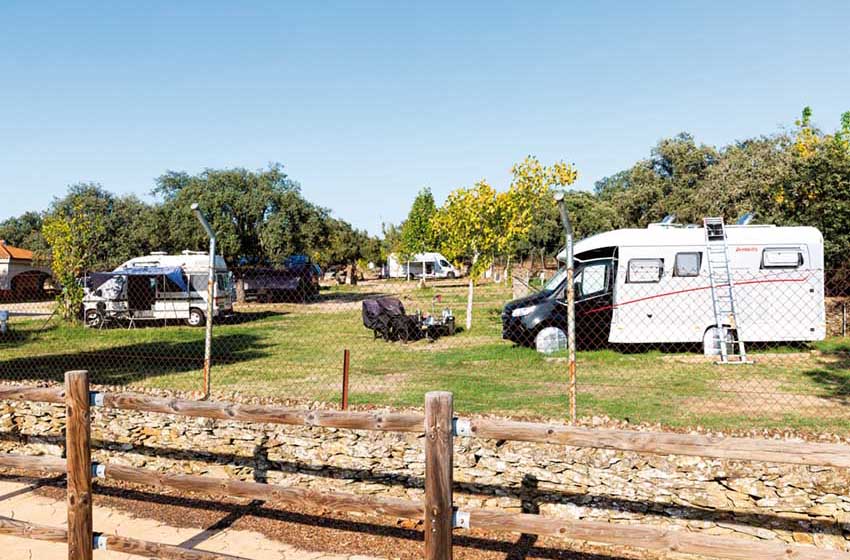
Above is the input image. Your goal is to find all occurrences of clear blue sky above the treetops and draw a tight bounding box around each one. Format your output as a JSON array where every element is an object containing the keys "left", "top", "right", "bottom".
[{"left": 0, "top": 1, "right": 850, "bottom": 233}]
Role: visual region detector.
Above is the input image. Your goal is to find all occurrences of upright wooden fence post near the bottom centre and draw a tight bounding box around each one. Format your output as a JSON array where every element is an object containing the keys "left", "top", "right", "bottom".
[{"left": 425, "top": 391, "right": 454, "bottom": 560}]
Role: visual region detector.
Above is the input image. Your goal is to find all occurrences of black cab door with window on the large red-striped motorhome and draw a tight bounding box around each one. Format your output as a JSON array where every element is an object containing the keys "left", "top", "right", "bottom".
[{"left": 573, "top": 259, "right": 614, "bottom": 348}]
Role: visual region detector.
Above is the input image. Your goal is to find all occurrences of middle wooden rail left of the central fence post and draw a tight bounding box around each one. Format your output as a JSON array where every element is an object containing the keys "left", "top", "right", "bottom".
[{"left": 0, "top": 453, "right": 425, "bottom": 519}]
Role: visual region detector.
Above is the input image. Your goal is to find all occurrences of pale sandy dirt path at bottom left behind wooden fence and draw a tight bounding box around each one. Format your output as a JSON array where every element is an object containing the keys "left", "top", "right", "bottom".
[{"left": 0, "top": 480, "right": 380, "bottom": 560}]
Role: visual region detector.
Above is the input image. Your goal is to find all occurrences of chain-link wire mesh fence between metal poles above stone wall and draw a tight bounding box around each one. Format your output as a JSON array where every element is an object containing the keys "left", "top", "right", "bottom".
[{"left": 0, "top": 257, "right": 850, "bottom": 429}]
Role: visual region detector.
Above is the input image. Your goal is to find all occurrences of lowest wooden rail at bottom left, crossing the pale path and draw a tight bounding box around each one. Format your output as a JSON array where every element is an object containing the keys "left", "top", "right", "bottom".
[{"left": 0, "top": 516, "right": 246, "bottom": 560}]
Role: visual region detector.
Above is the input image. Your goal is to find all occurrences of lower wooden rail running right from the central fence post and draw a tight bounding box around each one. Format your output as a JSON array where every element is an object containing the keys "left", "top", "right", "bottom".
[{"left": 469, "top": 509, "right": 850, "bottom": 560}]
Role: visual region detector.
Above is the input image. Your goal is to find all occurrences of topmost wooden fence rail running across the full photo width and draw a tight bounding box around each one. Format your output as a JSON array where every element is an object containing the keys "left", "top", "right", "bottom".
[{"left": 0, "top": 380, "right": 850, "bottom": 467}]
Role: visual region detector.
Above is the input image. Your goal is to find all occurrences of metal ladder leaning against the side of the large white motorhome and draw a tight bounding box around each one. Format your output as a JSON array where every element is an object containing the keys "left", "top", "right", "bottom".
[{"left": 703, "top": 218, "right": 750, "bottom": 364}]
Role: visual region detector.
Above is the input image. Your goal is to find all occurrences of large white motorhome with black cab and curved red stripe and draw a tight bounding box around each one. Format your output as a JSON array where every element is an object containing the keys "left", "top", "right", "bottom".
[{"left": 502, "top": 223, "right": 826, "bottom": 353}]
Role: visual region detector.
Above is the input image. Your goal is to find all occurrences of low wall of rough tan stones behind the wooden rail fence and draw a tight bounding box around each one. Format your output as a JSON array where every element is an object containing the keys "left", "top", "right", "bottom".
[{"left": 0, "top": 395, "right": 850, "bottom": 550}]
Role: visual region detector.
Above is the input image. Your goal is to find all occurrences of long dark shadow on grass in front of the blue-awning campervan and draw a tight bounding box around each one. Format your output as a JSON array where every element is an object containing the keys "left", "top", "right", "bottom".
[{"left": 0, "top": 331, "right": 268, "bottom": 385}]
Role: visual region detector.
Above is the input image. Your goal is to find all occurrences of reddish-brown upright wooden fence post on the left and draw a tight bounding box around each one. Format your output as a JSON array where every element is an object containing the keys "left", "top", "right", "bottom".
[{"left": 65, "top": 371, "right": 93, "bottom": 560}]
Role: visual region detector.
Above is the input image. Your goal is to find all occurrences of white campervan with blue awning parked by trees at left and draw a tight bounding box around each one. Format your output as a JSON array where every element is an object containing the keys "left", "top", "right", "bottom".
[{"left": 83, "top": 251, "right": 235, "bottom": 327}]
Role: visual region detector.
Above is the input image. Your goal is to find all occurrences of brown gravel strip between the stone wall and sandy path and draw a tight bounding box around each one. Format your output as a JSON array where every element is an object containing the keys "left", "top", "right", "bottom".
[{"left": 0, "top": 473, "right": 644, "bottom": 560}]
